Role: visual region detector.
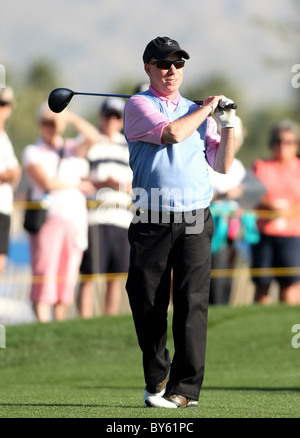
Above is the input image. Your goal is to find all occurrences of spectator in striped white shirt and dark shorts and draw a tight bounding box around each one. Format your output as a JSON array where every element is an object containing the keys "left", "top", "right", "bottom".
[{"left": 79, "top": 98, "right": 132, "bottom": 318}]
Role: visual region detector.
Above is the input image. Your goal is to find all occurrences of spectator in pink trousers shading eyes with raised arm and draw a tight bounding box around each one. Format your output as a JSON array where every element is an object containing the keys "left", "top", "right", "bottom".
[{"left": 23, "top": 104, "right": 99, "bottom": 322}]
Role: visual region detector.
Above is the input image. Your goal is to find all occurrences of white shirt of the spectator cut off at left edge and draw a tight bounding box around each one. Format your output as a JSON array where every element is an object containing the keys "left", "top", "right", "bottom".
[{"left": 0, "top": 131, "right": 19, "bottom": 215}]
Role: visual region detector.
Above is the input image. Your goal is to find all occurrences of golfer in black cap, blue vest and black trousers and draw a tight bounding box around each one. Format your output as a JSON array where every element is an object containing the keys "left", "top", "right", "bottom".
[{"left": 124, "top": 37, "right": 235, "bottom": 408}]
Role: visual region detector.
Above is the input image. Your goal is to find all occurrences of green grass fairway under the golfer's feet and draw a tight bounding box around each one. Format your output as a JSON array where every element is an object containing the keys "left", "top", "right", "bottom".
[{"left": 0, "top": 305, "right": 300, "bottom": 419}]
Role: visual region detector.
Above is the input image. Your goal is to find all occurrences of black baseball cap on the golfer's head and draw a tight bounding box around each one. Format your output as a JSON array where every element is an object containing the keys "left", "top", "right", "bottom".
[{"left": 143, "top": 37, "right": 190, "bottom": 64}]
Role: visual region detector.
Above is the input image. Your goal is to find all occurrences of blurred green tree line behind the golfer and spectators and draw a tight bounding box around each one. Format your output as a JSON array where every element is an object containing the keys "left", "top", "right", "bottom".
[{"left": 6, "top": 59, "right": 300, "bottom": 171}]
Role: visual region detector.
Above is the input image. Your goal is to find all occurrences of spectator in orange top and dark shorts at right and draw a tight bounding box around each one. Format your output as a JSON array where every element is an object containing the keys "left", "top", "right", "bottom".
[{"left": 252, "top": 120, "right": 300, "bottom": 305}]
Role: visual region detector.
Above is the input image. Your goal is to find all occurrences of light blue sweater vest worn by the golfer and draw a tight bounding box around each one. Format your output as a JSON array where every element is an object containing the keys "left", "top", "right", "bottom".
[{"left": 125, "top": 90, "right": 212, "bottom": 212}]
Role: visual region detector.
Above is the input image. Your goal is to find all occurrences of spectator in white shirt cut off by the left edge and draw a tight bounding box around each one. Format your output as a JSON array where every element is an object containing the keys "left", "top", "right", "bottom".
[{"left": 0, "top": 87, "right": 21, "bottom": 274}]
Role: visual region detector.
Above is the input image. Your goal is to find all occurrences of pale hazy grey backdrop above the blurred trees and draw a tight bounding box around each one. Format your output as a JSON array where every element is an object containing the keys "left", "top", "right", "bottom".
[{"left": 0, "top": 0, "right": 300, "bottom": 113}]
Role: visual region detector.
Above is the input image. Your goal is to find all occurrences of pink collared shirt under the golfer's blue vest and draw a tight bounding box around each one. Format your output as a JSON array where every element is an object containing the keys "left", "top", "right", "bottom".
[{"left": 124, "top": 86, "right": 220, "bottom": 167}]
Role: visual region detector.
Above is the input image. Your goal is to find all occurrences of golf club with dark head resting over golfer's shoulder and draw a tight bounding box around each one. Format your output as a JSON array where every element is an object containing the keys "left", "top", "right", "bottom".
[{"left": 48, "top": 88, "right": 237, "bottom": 113}]
